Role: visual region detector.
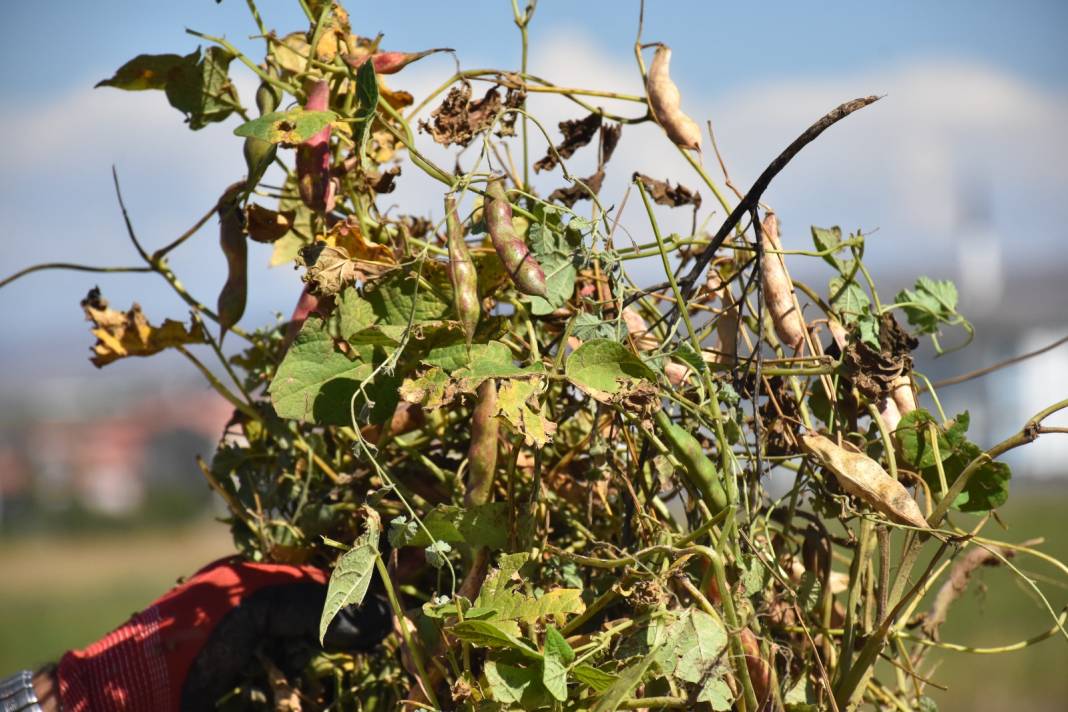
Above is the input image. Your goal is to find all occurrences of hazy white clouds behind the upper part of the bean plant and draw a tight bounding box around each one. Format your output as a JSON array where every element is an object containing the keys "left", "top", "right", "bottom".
[{"left": 8, "top": 30, "right": 1068, "bottom": 371}]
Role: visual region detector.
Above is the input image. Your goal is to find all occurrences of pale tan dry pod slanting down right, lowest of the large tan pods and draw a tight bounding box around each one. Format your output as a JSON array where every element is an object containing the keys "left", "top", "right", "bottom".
[{"left": 801, "top": 432, "right": 928, "bottom": 529}]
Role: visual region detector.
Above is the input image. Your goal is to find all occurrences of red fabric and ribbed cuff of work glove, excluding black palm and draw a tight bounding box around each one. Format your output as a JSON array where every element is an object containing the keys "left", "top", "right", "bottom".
[{"left": 58, "top": 558, "right": 327, "bottom": 712}]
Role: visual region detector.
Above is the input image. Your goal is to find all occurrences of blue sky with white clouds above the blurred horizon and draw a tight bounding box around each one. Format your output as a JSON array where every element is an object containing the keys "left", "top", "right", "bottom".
[{"left": 0, "top": 0, "right": 1068, "bottom": 405}]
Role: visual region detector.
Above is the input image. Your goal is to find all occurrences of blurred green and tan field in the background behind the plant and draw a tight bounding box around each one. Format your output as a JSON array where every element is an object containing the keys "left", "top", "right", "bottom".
[{"left": 0, "top": 486, "right": 1068, "bottom": 712}]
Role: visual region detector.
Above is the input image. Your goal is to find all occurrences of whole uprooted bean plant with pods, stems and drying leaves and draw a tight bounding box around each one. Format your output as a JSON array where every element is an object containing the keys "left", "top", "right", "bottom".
[{"left": 7, "top": 0, "right": 1068, "bottom": 712}]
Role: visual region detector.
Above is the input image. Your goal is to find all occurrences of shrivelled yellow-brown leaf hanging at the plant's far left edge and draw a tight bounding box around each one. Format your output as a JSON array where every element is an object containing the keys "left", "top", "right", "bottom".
[{"left": 81, "top": 287, "right": 207, "bottom": 368}]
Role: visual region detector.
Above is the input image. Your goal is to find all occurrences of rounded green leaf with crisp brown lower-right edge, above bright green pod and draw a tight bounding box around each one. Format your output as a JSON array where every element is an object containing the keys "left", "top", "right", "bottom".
[{"left": 564, "top": 339, "right": 656, "bottom": 402}]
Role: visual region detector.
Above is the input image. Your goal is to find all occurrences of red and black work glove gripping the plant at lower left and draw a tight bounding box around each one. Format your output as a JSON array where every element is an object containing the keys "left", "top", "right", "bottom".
[{"left": 56, "top": 558, "right": 392, "bottom": 712}]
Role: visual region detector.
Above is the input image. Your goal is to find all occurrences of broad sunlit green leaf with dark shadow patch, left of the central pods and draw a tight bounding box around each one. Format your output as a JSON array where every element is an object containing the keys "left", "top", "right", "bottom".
[{"left": 267, "top": 315, "right": 372, "bottom": 425}]
